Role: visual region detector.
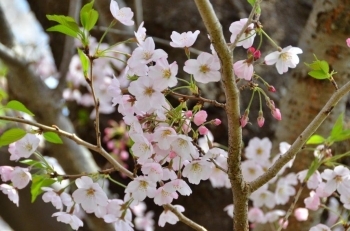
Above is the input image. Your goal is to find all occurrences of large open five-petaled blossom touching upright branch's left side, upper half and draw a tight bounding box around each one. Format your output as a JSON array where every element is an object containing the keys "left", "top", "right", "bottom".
[{"left": 183, "top": 52, "right": 221, "bottom": 83}]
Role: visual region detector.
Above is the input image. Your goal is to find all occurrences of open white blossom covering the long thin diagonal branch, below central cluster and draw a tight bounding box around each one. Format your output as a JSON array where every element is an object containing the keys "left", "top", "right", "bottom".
[{"left": 125, "top": 176, "right": 156, "bottom": 201}]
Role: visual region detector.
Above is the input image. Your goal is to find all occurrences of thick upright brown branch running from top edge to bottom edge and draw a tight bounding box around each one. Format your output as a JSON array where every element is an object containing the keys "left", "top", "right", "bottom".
[{"left": 195, "top": 0, "right": 250, "bottom": 231}]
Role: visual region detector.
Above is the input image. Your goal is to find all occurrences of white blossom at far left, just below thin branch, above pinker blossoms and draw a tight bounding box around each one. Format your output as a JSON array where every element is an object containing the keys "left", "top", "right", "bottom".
[{"left": 8, "top": 133, "right": 40, "bottom": 161}]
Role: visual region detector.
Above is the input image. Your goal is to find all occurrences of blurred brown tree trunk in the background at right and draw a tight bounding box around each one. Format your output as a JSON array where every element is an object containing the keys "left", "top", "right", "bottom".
[{"left": 255, "top": 0, "right": 350, "bottom": 231}]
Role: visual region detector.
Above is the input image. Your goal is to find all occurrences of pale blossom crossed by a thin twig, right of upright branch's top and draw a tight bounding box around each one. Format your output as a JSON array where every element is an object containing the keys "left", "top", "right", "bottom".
[{"left": 229, "top": 18, "right": 256, "bottom": 49}]
